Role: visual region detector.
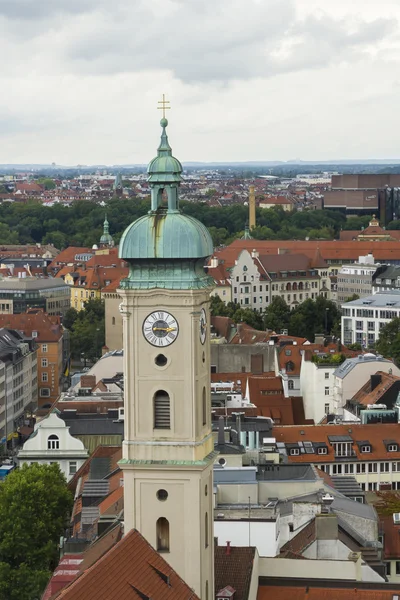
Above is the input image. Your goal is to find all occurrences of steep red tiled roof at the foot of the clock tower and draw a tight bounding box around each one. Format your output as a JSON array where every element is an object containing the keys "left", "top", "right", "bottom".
[{"left": 56, "top": 529, "right": 199, "bottom": 600}]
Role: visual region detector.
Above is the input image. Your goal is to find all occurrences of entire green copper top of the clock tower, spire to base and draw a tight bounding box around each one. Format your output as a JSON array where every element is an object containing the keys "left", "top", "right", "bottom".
[{"left": 119, "top": 117, "right": 213, "bottom": 289}]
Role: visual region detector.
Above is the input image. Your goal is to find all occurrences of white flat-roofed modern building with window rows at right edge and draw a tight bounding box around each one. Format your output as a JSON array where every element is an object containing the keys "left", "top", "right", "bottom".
[{"left": 342, "top": 290, "right": 400, "bottom": 348}]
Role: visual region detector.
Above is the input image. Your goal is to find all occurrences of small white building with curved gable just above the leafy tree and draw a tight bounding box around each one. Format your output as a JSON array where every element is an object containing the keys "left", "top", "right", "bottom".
[{"left": 18, "top": 412, "right": 89, "bottom": 481}]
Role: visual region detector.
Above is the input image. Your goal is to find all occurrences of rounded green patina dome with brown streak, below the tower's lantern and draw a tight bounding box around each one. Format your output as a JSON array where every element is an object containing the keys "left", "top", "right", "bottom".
[{"left": 119, "top": 209, "right": 213, "bottom": 260}]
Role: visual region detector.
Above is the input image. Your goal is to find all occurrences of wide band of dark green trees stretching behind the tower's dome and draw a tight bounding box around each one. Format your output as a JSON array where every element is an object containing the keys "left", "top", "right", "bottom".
[{"left": 0, "top": 198, "right": 382, "bottom": 249}]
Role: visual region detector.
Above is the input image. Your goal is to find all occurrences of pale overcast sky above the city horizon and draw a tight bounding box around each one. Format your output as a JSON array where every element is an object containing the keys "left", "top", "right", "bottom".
[{"left": 0, "top": 0, "right": 400, "bottom": 165}]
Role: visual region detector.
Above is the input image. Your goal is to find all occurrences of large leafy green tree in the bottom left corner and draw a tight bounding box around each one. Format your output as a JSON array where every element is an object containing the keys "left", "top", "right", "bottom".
[{"left": 0, "top": 464, "right": 73, "bottom": 600}]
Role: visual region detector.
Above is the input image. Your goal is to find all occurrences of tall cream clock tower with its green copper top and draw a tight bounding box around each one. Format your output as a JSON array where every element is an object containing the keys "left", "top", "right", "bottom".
[{"left": 118, "top": 117, "right": 215, "bottom": 600}]
